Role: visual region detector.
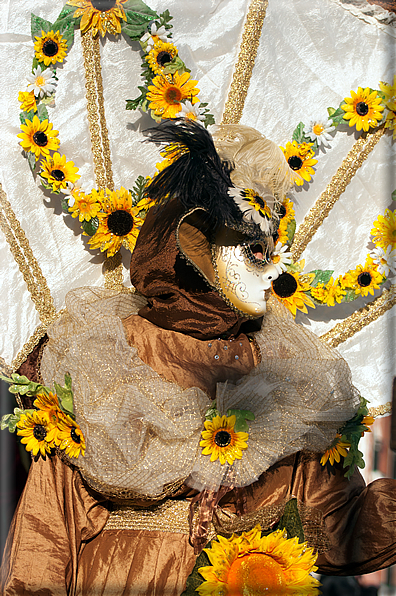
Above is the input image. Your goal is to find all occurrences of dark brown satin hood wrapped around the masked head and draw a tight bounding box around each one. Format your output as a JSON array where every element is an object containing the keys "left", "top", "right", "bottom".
[{"left": 131, "top": 200, "right": 254, "bottom": 339}]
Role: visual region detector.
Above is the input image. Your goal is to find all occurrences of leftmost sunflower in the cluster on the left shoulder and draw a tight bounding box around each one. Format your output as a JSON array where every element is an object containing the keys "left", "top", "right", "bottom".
[{"left": 17, "top": 411, "right": 56, "bottom": 458}]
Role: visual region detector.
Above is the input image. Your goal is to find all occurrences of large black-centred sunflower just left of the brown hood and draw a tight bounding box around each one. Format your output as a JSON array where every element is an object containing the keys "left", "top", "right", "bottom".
[{"left": 88, "top": 187, "right": 143, "bottom": 257}]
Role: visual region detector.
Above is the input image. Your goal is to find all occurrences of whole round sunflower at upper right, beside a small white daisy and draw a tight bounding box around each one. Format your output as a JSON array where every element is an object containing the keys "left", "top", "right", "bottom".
[{"left": 341, "top": 87, "right": 385, "bottom": 131}]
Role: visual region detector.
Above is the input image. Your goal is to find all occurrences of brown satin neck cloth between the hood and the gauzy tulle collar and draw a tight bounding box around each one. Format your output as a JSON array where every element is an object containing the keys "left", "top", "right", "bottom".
[{"left": 123, "top": 315, "right": 259, "bottom": 397}]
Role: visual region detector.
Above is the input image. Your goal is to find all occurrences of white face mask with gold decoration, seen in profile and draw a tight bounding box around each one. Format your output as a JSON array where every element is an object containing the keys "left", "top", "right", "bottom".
[{"left": 214, "top": 244, "right": 279, "bottom": 317}]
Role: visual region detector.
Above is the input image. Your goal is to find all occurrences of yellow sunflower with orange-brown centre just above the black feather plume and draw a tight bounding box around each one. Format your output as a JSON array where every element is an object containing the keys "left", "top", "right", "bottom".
[{"left": 146, "top": 72, "right": 199, "bottom": 118}]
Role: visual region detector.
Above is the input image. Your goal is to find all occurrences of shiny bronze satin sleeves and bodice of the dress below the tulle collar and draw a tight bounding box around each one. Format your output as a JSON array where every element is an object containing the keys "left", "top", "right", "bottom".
[{"left": 0, "top": 453, "right": 396, "bottom": 596}]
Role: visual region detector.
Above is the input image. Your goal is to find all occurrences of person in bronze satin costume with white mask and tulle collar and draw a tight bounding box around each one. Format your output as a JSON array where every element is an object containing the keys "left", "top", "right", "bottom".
[{"left": 1, "top": 121, "right": 396, "bottom": 596}]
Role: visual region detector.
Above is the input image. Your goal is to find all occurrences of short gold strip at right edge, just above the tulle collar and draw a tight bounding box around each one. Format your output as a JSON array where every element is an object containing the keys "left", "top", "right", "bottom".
[{"left": 319, "top": 286, "right": 396, "bottom": 348}]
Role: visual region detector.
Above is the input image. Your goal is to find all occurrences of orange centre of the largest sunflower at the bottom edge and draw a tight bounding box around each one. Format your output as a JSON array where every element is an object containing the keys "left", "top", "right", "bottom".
[{"left": 227, "top": 553, "right": 287, "bottom": 596}]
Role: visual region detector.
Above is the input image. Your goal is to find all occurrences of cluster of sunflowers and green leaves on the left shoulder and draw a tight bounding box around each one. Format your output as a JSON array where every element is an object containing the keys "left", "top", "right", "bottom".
[{"left": 0, "top": 373, "right": 85, "bottom": 459}]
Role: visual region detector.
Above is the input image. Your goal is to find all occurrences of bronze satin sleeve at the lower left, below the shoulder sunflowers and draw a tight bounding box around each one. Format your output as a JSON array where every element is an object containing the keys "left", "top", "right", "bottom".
[{"left": 0, "top": 456, "right": 109, "bottom": 596}]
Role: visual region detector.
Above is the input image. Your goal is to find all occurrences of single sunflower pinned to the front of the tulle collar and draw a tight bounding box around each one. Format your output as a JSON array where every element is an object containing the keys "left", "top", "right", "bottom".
[{"left": 199, "top": 416, "right": 249, "bottom": 466}]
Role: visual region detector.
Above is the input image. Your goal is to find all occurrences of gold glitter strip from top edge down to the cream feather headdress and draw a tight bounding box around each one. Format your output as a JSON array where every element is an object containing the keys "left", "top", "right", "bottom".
[{"left": 221, "top": 0, "right": 268, "bottom": 124}]
